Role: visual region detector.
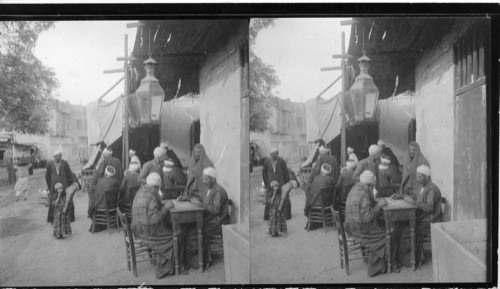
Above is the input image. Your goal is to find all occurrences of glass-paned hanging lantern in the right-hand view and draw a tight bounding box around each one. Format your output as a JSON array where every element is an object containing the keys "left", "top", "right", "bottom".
[{"left": 344, "top": 55, "right": 379, "bottom": 122}]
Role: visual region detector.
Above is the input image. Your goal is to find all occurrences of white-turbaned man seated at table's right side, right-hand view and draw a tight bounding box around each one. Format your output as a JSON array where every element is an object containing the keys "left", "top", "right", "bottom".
[{"left": 415, "top": 165, "right": 443, "bottom": 267}]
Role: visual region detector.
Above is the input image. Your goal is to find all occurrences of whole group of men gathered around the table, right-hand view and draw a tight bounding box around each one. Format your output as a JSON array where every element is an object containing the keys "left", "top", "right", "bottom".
[{"left": 304, "top": 140, "right": 442, "bottom": 276}]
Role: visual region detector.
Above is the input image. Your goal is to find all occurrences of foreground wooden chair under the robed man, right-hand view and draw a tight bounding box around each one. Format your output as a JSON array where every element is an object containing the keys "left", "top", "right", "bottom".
[{"left": 330, "top": 206, "right": 367, "bottom": 275}]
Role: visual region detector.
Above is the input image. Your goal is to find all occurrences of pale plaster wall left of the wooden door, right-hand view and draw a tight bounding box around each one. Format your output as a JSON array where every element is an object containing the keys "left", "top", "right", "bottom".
[{"left": 415, "top": 21, "right": 471, "bottom": 220}]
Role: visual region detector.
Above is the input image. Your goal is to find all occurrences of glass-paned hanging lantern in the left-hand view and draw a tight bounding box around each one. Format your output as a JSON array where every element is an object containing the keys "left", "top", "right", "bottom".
[{"left": 135, "top": 57, "right": 165, "bottom": 124}]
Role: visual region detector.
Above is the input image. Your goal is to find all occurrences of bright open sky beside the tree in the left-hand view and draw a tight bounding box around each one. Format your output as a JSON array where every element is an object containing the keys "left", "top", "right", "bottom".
[{"left": 34, "top": 21, "right": 136, "bottom": 105}]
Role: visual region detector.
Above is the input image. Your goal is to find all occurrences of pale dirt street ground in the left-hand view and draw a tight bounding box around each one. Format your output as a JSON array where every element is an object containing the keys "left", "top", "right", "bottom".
[{"left": 0, "top": 169, "right": 225, "bottom": 287}]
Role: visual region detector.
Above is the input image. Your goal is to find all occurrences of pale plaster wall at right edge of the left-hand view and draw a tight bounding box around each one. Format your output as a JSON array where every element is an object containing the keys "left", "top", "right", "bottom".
[{"left": 200, "top": 28, "right": 249, "bottom": 223}]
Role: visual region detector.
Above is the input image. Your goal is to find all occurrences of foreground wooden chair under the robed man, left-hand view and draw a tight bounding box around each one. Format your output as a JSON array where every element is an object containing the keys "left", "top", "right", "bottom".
[{"left": 116, "top": 209, "right": 156, "bottom": 277}]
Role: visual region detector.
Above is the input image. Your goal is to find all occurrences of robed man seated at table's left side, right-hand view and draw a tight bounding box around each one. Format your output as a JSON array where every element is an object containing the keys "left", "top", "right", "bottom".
[{"left": 345, "top": 170, "right": 398, "bottom": 277}]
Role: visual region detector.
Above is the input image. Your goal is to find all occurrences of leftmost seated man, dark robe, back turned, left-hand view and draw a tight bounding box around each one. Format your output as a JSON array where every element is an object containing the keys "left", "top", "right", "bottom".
[{"left": 88, "top": 166, "right": 120, "bottom": 232}]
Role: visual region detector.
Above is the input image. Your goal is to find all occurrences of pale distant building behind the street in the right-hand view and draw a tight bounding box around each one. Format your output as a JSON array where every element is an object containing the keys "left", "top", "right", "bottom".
[{"left": 250, "top": 98, "right": 308, "bottom": 162}]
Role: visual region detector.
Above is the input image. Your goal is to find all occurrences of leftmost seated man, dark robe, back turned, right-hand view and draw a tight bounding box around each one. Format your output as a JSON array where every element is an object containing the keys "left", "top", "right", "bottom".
[{"left": 304, "top": 163, "right": 335, "bottom": 229}]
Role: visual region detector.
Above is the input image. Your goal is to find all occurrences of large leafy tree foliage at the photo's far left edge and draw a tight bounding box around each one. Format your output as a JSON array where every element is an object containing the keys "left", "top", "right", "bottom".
[{"left": 0, "top": 21, "right": 57, "bottom": 133}]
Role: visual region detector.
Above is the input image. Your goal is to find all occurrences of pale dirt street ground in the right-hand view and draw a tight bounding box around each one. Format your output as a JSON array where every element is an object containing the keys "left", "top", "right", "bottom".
[{"left": 250, "top": 164, "right": 432, "bottom": 284}]
